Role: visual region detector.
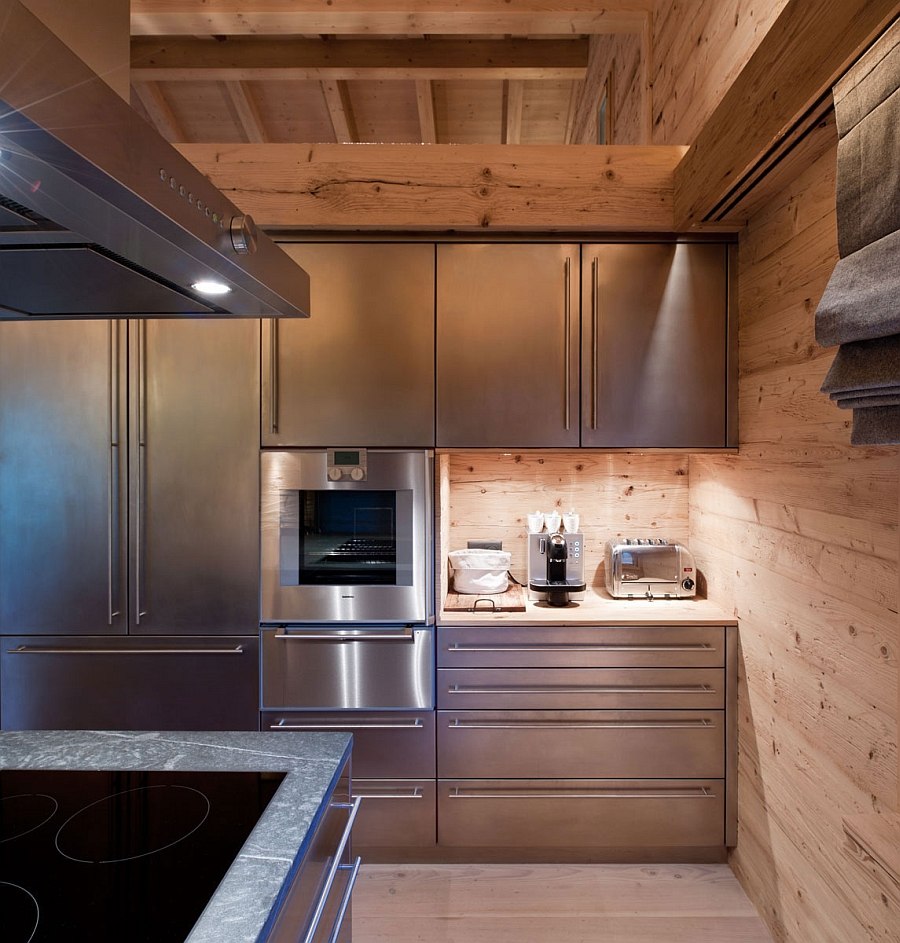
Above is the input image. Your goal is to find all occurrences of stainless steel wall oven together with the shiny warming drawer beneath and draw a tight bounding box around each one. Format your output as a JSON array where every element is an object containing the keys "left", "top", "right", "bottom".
[{"left": 260, "top": 449, "right": 434, "bottom": 719}]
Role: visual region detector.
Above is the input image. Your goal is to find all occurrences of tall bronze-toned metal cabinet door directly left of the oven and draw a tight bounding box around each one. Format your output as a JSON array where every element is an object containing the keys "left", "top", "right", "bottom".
[{"left": 129, "top": 319, "right": 259, "bottom": 635}]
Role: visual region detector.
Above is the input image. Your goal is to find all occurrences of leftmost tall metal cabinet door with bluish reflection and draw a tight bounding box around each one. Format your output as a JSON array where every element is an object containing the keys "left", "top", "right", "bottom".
[{"left": 0, "top": 321, "right": 127, "bottom": 635}]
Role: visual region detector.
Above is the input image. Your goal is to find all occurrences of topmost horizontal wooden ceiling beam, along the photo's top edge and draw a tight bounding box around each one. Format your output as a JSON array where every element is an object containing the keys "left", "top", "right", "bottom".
[{"left": 131, "top": 0, "right": 655, "bottom": 36}]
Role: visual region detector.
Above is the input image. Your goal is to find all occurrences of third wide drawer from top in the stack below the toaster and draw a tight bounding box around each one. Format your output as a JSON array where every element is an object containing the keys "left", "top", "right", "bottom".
[{"left": 438, "top": 710, "right": 725, "bottom": 779}]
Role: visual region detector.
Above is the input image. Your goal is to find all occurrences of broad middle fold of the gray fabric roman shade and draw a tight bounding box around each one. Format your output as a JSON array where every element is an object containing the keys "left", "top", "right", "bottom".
[{"left": 816, "top": 229, "right": 900, "bottom": 347}]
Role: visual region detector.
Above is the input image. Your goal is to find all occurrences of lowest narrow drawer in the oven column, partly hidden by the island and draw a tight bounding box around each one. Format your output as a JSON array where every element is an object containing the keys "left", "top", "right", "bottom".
[{"left": 353, "top": 780, "right": 437, "bottom": 861}]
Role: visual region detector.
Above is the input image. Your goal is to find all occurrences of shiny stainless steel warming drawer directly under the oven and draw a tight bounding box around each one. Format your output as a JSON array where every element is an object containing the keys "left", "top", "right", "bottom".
[{"left": 262, "top": 626, "right": 434, "bottom": 711}]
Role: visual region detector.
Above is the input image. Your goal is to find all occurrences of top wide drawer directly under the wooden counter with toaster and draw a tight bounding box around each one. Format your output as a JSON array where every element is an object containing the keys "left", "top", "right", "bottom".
[{"left": 438, "top": 625, "right": 725, "bottom": 668}]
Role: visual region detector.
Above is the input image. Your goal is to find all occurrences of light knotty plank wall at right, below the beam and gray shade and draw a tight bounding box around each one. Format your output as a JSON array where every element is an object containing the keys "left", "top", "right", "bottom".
[{"left": 690, "top": 148, "right": 900, "bottom": 943}]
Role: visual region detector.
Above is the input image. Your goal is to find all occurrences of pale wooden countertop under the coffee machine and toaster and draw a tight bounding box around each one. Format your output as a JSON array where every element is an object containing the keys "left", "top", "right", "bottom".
[{"left": 437, "top": 588, "right": 737, "bottom": 625}]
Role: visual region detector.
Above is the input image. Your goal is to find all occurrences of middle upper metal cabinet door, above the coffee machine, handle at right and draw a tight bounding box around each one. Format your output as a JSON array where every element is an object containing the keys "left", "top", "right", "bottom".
[{"left": 437, "top": 244, "right": 579, "bottom": 448}]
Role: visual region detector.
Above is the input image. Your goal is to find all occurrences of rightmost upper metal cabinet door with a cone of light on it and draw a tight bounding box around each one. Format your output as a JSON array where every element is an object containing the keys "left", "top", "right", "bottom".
[{"left": 581, "top": 243, "right": 728, "bottom": 448}]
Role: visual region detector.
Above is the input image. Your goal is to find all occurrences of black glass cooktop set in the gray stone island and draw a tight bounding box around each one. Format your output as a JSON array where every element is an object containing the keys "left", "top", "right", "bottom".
[{"left": 0, "top": 770, "right": 285, "bottom": 943}]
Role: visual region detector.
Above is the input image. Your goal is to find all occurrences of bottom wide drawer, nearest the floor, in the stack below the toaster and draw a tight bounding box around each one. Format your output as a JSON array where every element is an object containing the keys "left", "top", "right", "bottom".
[{"left": 438, "top": 779, "right": 725, "bottom": 849}]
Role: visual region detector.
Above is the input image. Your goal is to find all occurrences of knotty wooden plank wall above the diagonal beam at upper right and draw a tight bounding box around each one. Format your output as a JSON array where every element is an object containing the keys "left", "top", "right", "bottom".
[{"left": 651, "top": 0, "right": 786, "bottom": 144}]
